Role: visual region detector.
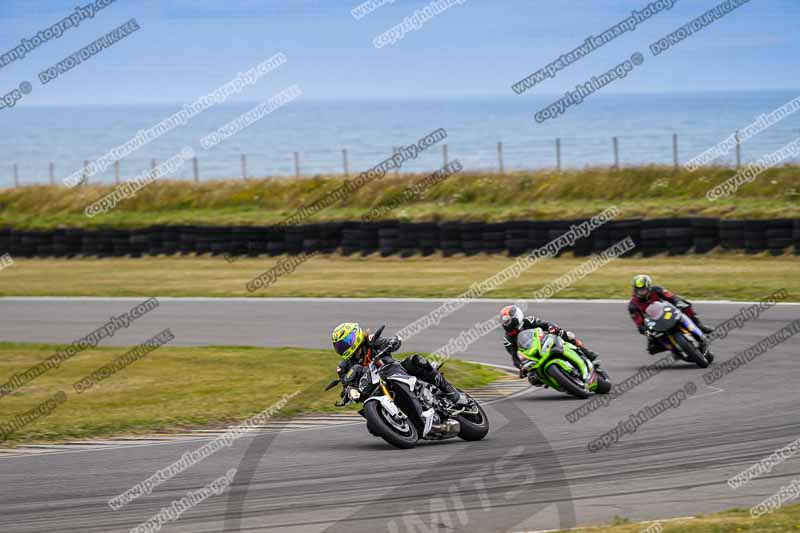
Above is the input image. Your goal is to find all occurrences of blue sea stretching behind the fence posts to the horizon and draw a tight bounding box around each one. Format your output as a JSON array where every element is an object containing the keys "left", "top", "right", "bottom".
[{"left": 0, "top": 90, "right": 800, "bottom": 187}]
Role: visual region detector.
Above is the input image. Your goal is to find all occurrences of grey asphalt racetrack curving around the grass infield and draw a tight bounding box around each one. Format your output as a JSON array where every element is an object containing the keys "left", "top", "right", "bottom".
[{"left": 0, "top": 298, "right": 800, "bottom": 532}]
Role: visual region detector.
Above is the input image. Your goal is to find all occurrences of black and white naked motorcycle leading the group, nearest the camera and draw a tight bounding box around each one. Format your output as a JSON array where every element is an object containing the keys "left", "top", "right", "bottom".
[{"left": 325, "top": 326, "right": 489, "bottom": 448}]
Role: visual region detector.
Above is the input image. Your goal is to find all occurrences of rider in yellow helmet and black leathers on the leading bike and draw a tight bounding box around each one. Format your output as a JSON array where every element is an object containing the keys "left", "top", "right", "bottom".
[{"left": 331, "top": 322, "right": 469, "bottom": 406}]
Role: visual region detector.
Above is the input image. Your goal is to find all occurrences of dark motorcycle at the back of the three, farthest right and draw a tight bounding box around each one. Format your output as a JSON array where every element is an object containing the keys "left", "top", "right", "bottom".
[{"left": 644, "top": 302, "right": 714, "bottom": 368}]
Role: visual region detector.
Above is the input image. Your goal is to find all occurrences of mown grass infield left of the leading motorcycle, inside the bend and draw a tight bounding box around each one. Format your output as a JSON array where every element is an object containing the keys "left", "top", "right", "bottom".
[{"left": 0, "top": 343, "right": 501, "bottom": 447}]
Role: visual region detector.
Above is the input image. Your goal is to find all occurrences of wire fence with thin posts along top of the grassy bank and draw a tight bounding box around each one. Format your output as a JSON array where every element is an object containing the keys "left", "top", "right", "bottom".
[{"left": 6, "top": 132, "right": 788, "bottom": 187}]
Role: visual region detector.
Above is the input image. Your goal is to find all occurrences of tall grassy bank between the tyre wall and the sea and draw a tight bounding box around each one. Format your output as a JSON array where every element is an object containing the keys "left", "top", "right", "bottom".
[{"left": 0, "top": 166, "right": 800, "bottom": 229}]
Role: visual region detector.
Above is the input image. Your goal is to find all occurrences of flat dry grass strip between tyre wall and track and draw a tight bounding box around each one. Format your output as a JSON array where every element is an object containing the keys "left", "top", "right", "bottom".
[{"left": 0, "top": 253, "right": 800, "bottom": 301}]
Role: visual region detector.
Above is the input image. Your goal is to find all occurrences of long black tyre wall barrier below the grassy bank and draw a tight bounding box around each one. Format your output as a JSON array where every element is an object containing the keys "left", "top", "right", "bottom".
[{"left": 0, "top": 217, "right": 800, "bottom": 258}]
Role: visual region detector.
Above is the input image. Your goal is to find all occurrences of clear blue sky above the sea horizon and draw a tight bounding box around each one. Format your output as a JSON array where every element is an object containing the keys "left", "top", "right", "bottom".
[{"left": 0, "top": 0, "right": 800, "bottom": 105}]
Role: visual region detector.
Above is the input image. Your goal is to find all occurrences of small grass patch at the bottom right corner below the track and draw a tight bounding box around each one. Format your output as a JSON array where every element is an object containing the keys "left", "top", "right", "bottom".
[{"left": 562, "top": 504, "right": 800, "bottom": 533}]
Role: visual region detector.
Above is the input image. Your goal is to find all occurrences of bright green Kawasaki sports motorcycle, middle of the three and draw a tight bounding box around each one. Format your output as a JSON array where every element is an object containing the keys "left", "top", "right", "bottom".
[{"left": 517, "top": 328, "right": 611, "bottom": 398}]
